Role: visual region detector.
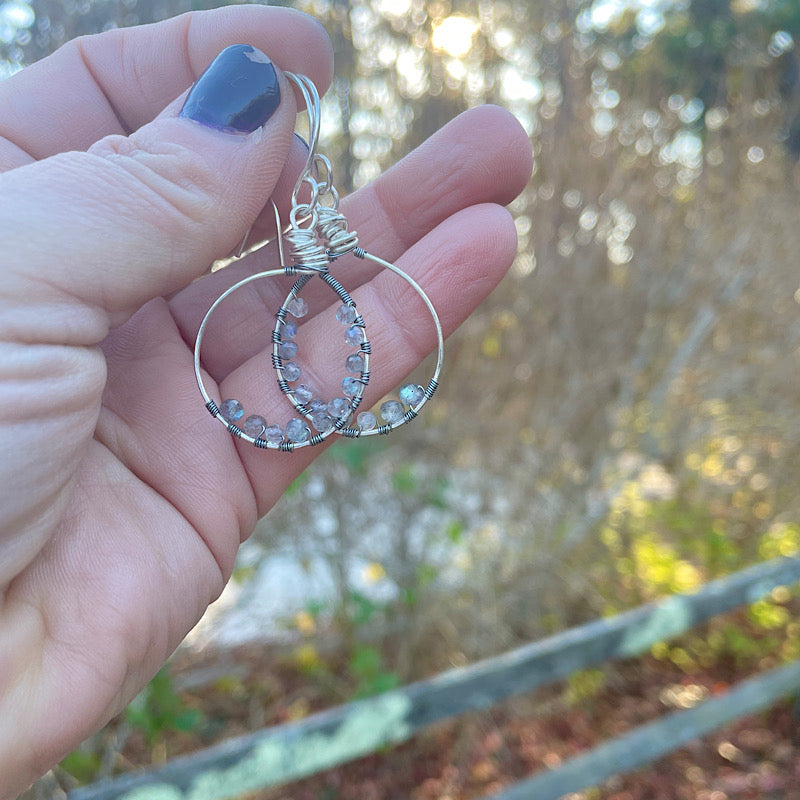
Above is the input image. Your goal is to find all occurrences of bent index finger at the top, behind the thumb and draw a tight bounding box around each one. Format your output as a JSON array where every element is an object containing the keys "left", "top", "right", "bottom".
[{"left": 0, "top": 5, "right": 332, "bottom": 170}]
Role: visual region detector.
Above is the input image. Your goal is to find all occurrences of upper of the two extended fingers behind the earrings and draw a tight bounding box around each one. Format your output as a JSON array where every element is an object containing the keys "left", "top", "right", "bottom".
[{"left": 171, "top": 106, "right": 531, "bottom": 380}]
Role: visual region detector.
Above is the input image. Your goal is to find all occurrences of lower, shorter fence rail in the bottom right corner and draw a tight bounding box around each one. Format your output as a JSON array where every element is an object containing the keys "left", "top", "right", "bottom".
[{"left": 485, "top": 661, "right": 800, "bottom": 800}]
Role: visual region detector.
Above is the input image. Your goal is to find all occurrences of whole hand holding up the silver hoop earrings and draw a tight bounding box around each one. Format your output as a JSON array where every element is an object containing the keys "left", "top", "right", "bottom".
[{"left": 0, "top": 6, "right": 531, "bottom": 798}]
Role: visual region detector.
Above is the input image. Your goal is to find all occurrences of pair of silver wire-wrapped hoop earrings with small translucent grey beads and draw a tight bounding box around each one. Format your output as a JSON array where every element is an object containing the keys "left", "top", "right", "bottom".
[{"left": 194, "top": 72, "right": 444, "bottom": 452}]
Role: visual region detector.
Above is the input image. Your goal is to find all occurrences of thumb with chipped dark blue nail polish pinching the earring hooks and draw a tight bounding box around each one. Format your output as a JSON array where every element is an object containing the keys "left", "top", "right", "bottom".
[{"left": 0, "top": 45, "right": 296, "bottom": 344}]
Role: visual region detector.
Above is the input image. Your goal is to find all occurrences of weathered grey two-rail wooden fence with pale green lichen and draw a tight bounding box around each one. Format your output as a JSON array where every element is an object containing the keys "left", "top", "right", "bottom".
[{"left": 69, "top": 558, "right": 800, "bottom": 800}]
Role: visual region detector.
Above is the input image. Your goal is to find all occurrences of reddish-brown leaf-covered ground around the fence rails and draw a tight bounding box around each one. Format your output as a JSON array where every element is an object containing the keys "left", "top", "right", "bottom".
[{"left": 98, "top": 628, "right": 800, "bottom": 800}]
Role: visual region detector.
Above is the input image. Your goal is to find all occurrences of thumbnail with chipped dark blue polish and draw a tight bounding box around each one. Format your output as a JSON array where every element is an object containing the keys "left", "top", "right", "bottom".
[{"left": 180, "top": 44, "right": 281, "bottom": 133}]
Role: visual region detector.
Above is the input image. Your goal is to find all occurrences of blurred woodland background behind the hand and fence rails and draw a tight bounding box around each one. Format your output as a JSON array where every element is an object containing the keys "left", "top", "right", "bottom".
[{"left": 7, "top": 0, "right": 800, "bottom": 800}]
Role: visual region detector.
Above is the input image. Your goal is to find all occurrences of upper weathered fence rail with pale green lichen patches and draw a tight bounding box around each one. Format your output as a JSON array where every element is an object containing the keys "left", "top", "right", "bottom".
[{"left": 69, "top": 558, "right": 800, "bottom": 800}]
